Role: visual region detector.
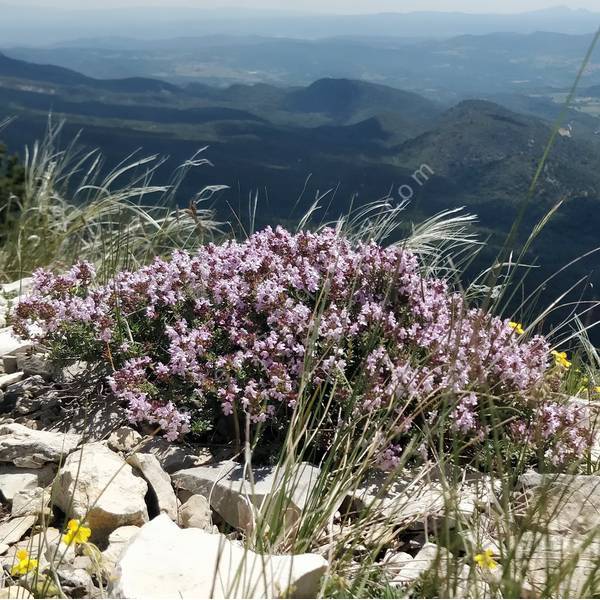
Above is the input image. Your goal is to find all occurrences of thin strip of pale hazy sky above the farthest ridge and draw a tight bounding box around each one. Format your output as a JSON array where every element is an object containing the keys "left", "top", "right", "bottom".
[{"left": 23, "top": 0, "right": 600, "bottom": 13}]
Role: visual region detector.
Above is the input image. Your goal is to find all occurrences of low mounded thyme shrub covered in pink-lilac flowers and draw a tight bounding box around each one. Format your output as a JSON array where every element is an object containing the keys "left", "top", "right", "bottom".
[{"left": 14, "top": 228, "right": 586, "bottom": 464}]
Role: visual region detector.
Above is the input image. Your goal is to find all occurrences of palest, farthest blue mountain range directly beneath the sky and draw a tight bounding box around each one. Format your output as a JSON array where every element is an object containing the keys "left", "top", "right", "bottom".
[{"left": 0, "top": 2, "right": 600, "bottom": 45}]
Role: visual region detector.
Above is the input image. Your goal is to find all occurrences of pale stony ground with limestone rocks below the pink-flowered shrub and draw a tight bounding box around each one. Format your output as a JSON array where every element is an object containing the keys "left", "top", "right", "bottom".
[{"left": 0, "top": 286, "right": 600, "bottom": 598}]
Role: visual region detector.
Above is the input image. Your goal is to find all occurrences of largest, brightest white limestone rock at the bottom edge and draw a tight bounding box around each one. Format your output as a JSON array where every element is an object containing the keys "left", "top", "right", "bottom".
[{"left": 109, "top": 515, "right": 327, "bottom": 599}]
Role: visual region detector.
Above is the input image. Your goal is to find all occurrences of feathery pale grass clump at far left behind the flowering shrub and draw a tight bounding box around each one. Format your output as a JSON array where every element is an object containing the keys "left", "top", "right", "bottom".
[{"left": 0, "top": 121, "right": 223, "bottom": 281}]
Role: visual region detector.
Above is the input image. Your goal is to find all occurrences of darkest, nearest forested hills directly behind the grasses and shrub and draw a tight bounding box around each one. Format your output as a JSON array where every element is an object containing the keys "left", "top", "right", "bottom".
[{"left": 0, "top": 55, "right": 600, "bottom": 324}]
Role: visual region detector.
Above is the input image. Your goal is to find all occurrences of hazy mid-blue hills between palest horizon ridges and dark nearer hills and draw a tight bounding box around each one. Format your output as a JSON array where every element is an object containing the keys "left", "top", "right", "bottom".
[{"left": 5, "top": 30, "right": 600, "bottom": 98}]
